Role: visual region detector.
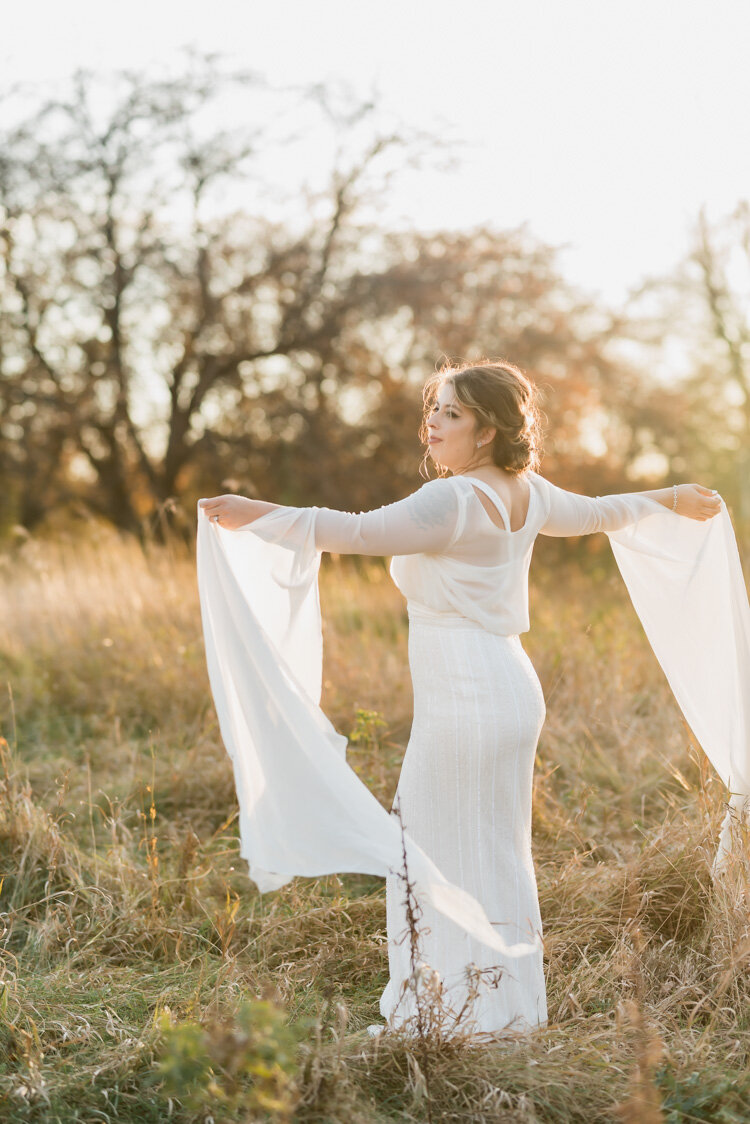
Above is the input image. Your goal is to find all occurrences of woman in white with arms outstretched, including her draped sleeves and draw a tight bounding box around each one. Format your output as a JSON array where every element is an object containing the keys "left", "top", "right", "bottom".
[{"left": 198, "top": 361, "right": 748, "bottom": 1032}]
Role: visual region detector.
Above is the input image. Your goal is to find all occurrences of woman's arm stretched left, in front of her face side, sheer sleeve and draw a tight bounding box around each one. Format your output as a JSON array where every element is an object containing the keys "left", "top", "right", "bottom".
[{"left": 200, "top": 479, "right": 459, "bottom": 555}]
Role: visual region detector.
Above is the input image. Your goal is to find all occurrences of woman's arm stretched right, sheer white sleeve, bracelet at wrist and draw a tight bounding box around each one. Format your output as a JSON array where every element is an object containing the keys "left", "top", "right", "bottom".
[{"left": 540, "top": 480, "right": 721, "bottom": 536}]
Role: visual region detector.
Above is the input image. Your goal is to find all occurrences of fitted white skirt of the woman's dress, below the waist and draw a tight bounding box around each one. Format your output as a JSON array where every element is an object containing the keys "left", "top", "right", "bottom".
[{"left": 380, "top": 602, "right": 546, "bottom": 1033}]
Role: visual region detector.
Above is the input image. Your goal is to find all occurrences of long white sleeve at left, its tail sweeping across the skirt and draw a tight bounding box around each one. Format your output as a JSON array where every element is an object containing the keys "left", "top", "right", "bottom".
[{"left": 197, "top": 501, "right": 541, "bottom": 958}]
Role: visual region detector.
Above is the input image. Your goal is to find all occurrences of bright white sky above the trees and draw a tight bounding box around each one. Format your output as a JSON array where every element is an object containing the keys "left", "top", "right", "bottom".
[{"left": 0, "top": 0, "right": 750, "bottom": 302}]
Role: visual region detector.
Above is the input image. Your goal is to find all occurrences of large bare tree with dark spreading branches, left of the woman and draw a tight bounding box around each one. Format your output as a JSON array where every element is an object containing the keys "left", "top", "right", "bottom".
[{"left": 0, "top": 57, "right": 445, "bottom": 531}]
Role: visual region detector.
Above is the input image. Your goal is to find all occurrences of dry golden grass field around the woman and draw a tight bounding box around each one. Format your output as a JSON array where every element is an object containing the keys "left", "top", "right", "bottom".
[{"left": 0, "top": 527, "right": 750, "bottom": 1124}]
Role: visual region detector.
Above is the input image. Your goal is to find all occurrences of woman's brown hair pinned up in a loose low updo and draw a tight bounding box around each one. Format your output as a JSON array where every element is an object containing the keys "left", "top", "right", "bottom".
[{"left": 419, "top": 359, "right": 542, "bottom": 477}]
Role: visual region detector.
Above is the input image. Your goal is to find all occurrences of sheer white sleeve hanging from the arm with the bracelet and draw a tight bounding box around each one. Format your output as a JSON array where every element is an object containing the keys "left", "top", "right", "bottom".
[{"left": 536, "top": 477, "right": 750, "bottom": 876}]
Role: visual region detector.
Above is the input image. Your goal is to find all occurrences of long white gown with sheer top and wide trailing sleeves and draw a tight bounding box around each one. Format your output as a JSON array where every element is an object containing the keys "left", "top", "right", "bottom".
[{"left": 198, "top": 472, "right": 750, "bottom": 1032}]
